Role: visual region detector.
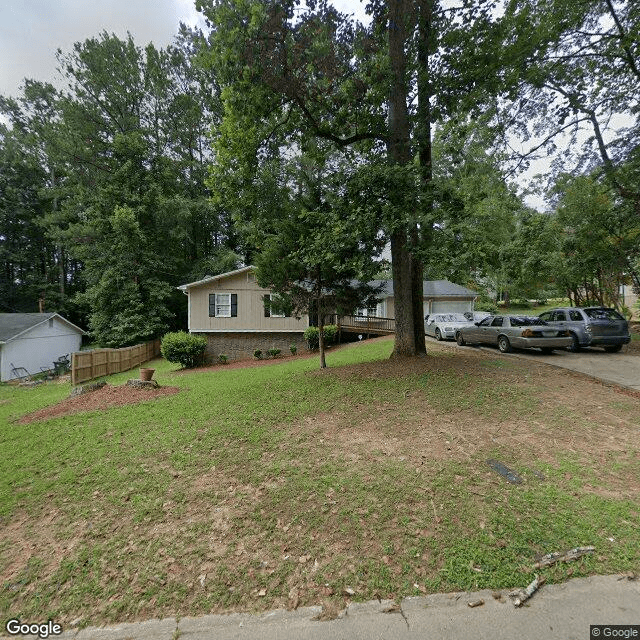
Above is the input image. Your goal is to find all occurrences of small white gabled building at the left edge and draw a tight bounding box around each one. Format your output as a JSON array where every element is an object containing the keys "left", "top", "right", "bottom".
[{"left": 0, "top": 313, "right": 85, "bottom": 382}]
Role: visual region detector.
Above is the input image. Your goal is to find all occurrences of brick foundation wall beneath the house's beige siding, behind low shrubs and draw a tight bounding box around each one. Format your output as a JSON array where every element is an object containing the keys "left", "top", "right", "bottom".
[{"left": 194, "top": 332, "right": 307, "bottom": 362}]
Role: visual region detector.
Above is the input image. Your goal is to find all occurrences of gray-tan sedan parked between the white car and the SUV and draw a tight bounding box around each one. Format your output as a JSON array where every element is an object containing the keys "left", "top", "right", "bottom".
[{"left": 456, "top": 316, "right": 572, "bottom": 353}]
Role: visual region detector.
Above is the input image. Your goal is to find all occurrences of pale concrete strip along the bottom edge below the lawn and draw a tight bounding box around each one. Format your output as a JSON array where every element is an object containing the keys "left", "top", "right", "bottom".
[{"left": 12, "top": 575, "right": 640, "bottom": 640}]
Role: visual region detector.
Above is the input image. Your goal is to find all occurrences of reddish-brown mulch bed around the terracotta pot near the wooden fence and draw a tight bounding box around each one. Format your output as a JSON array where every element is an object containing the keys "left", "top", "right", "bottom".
[{"left": 18, "top": 385, "right": 180, "bottom": 424}]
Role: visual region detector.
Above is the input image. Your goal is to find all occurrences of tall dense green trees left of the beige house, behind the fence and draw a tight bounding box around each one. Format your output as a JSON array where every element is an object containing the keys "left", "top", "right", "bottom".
[{"left": 0, "top": 28, "right": 240, "bottom": 346}]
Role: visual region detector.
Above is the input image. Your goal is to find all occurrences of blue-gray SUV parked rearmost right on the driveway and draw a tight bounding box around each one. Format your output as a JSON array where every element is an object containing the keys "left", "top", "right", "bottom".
[{"left": 539, "top": 307, "right": 631, "bottom": 352}]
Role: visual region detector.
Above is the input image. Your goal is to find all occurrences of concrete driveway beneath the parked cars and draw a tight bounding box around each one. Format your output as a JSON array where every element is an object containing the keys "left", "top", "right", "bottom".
[{"left": 427, "top": 338, "right": 640, "bottom": 391}]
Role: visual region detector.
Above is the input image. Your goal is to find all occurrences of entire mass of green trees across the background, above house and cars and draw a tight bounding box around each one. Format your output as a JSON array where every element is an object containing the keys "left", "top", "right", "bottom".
[{"left": 0, "top": 0, "right": 640, "bottom": 353}]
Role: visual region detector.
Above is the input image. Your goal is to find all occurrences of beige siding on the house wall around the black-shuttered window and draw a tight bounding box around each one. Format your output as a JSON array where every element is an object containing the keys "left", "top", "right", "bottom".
[{"left": 189, "top": 272, "right": 309, "bottom": 332}]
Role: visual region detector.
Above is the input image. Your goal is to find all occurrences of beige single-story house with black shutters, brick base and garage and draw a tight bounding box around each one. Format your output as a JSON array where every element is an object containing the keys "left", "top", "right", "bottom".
[{"left": 178, "top": 266, "right": 477, "bottom": 359}]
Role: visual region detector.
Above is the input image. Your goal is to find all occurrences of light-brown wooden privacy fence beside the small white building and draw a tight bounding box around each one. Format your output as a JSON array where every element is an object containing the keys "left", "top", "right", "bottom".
[{"left": 71, "top": 339, "right": 160, "bottom": 384}]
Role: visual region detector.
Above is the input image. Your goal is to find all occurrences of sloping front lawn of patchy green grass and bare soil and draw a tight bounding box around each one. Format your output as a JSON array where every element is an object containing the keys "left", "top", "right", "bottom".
[{"left": 0, "top": 339, "right": 640, "bottom": 625}]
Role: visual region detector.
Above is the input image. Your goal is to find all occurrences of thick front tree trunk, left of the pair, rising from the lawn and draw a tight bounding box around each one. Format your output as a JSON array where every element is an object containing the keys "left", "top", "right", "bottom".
[{"left": 387, "top": 0, "right": 424, "bottom": 356}]
